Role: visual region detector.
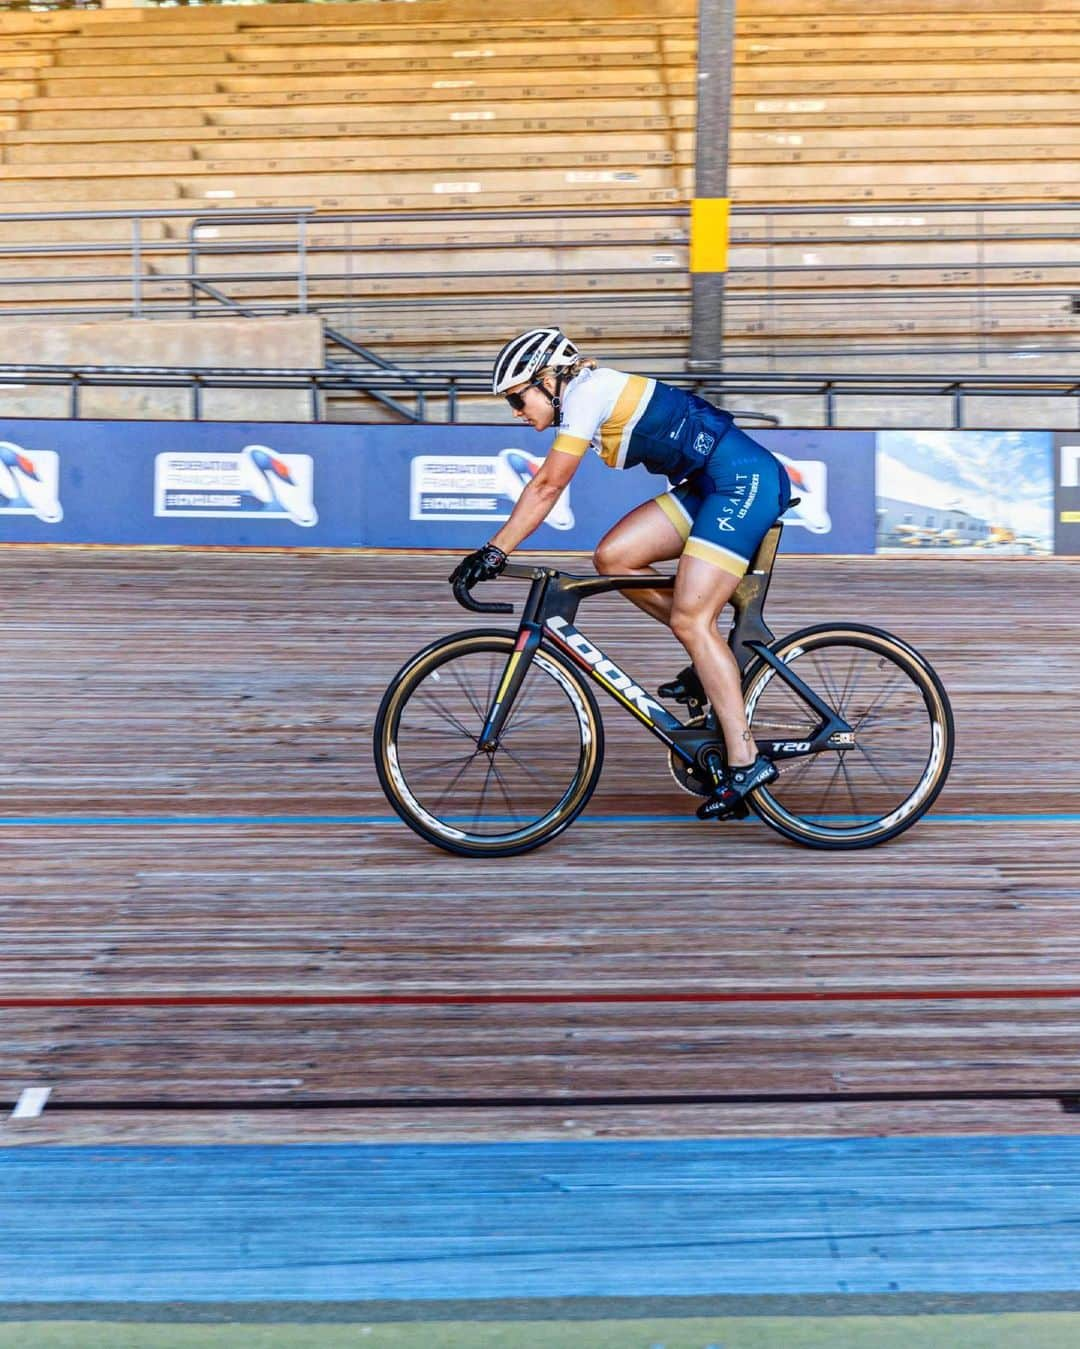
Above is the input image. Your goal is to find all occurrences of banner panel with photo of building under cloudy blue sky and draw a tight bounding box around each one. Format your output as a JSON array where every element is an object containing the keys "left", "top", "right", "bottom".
[{"left": 876, "top": 430, "right": 1053, "bottom": 556}]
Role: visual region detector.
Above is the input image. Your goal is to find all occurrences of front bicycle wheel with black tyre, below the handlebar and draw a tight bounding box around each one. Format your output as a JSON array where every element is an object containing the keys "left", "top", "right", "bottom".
[{"left": 373, "top": 629, "right": 604, "bottom": 857}]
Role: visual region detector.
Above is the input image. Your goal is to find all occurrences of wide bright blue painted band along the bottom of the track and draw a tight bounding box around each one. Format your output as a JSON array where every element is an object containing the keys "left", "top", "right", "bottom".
[{"left": 0, "top": 1136, "right": 1080, "bottom": 1303}]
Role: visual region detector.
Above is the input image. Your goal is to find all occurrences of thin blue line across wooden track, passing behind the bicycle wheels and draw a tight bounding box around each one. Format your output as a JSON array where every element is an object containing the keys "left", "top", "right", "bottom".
[{"left": 0, "top": 812, "right": 1080, "bottom": 828}]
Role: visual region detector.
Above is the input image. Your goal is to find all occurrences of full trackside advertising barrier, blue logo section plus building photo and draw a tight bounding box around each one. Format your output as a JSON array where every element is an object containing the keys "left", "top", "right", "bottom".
[{"left": 0, "top": 420, "right": 1062, "bottom": 557}]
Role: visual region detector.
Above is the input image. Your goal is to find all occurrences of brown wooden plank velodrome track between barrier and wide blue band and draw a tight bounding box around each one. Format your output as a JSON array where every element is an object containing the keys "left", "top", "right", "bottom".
[{"left": 0, "top": 548, "right": 1080, "bottom": 1144}]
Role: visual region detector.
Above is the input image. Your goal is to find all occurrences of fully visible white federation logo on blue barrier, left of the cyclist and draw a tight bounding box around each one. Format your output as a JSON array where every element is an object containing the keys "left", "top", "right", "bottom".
[{"left": 154, "top": 445, "right": 318, "bottom": 527}]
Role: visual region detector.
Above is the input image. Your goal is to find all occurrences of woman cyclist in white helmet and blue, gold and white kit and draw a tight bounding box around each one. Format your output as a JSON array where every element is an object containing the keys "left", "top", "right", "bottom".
[{"left": 450, "top": 328, "right": 791, "bottom": 820}]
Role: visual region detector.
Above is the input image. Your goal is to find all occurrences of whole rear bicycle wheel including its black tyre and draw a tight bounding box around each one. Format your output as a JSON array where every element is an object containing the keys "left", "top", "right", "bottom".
[{"left": 743, "top": 623, "right": 956, "bottom": 850}]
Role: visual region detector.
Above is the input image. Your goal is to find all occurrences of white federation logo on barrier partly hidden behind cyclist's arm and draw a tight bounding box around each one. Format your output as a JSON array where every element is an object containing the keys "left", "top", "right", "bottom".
[{"left": 409, "top": 448, "right": 574, "bottom": 530}]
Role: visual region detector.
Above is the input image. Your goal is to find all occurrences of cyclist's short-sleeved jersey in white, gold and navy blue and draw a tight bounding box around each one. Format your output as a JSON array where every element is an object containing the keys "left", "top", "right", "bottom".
[{"left": 551, "top": 368, "right": 731, "bottom": 483}]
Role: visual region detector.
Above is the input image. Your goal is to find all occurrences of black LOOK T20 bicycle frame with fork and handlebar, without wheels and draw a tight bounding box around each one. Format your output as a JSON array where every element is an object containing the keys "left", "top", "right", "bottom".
[{"left": 471, "top": 525, "right": 852, "bottom": 764}]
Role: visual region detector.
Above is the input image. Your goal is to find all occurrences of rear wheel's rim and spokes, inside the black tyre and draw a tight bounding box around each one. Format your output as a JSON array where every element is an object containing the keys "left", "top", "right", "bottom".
[{"left": 747, "top": 635, "right": 948, "bottom": 842}]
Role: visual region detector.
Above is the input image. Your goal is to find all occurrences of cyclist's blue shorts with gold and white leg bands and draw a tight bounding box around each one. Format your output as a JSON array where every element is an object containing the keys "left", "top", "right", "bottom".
[{"left": 655, "top": 426, "right": 791, "bottom": 576}]
